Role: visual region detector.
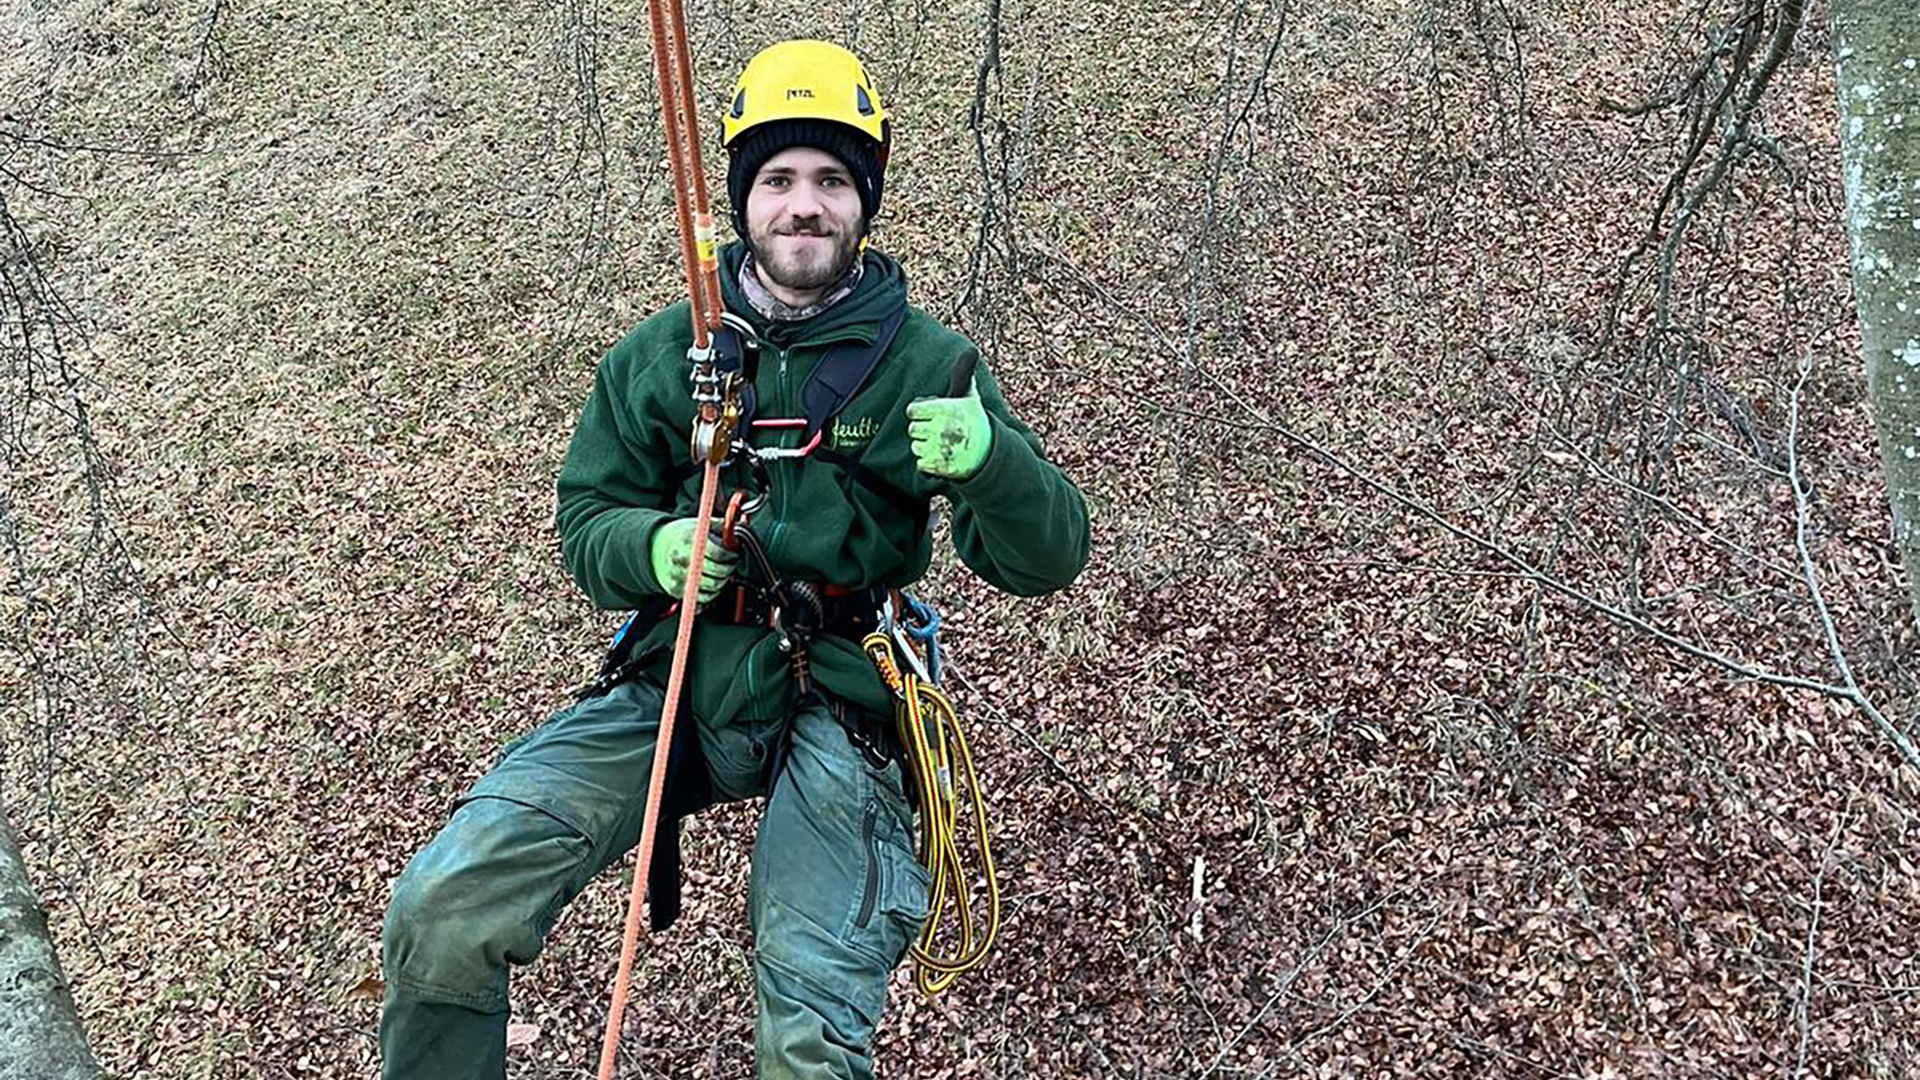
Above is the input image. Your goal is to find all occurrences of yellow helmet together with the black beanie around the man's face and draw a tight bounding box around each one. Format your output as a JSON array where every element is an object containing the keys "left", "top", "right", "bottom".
[{"left": 720, "top": 40, "right": 893, "bottom": 236}]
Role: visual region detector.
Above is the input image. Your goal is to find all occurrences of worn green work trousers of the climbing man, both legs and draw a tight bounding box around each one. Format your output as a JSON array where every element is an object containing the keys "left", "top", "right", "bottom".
[{"left": 380, "top": 680, "right": 927, "bottom": 1080}]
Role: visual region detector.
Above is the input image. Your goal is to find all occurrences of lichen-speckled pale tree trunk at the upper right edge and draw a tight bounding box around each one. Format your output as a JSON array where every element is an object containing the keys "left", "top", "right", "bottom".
[{"left": 1830, "top": 0, "right": 1920, "bottom": 623}]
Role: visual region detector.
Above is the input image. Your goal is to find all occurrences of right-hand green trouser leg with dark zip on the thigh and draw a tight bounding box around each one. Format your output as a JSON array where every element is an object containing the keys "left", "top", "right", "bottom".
[{"left": 749, "top": 707, "right": 927, "bottom": 1080}]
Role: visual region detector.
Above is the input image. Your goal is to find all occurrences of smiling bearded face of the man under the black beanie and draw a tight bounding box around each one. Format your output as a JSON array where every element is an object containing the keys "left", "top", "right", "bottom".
[{"left": 747, "top": 146, "right": 860, "bottom": 300}]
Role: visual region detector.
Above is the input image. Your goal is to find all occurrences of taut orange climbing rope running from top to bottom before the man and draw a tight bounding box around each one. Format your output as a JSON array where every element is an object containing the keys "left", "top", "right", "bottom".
[{"left": 599, "top": 0, "right": 735, "bottom": 1080}]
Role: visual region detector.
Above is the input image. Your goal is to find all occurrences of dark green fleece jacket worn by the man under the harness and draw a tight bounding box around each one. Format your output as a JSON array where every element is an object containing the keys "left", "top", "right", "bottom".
[{"left": 557, "top": 242, "right": 1087, "bottom": 724}]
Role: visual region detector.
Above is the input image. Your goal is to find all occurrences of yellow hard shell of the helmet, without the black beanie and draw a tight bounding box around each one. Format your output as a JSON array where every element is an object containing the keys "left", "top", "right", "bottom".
[{"left": 720, "top": 38, "right": 887, "bottom": 148}]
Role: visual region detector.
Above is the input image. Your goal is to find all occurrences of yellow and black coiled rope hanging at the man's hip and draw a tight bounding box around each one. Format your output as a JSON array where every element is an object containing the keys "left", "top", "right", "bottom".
[{"left": 860, "top": 634, "right": 1000, "bottom": 995}]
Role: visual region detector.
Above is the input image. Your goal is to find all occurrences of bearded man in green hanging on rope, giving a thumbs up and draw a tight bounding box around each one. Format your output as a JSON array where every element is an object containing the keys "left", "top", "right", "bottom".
[{"left": 380, "top": 40, "right": 1087, "bottom": 1080}]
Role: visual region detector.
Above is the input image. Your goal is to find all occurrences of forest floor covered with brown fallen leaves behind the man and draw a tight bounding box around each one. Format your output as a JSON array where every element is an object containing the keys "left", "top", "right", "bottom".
[{"left": 0, "top": 0, "right": 1920, "bottom": 1080}]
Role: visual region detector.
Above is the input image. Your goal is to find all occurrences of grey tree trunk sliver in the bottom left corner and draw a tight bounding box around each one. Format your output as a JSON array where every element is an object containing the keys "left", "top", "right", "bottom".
[{"left": 0, "top": 819, "right": 104, "bottom": 1080}]
